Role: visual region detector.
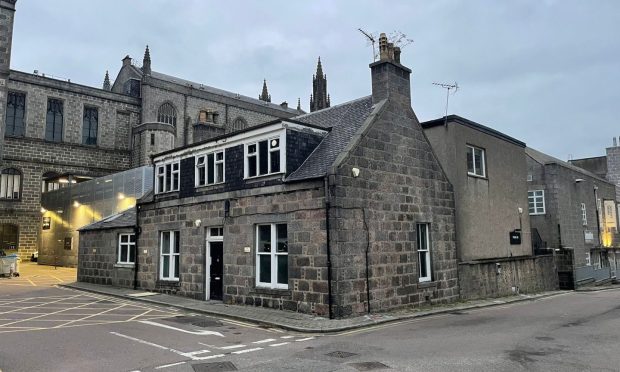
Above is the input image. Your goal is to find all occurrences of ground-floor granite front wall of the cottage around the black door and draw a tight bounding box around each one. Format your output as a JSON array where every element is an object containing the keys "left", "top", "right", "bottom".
[{"left": 138, "top": 182, "right": 328, "bottom": 315}]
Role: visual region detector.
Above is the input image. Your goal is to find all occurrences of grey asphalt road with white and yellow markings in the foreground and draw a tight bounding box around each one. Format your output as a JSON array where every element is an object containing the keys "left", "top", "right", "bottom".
[{"left": 0, "top": 282, "right": 620, "bottom": 372}]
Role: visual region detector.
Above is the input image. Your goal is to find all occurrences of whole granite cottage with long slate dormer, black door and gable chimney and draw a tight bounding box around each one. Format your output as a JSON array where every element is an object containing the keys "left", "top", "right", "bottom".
[{"left": 78, "top": 35, "right": 458, "bottom": 317}]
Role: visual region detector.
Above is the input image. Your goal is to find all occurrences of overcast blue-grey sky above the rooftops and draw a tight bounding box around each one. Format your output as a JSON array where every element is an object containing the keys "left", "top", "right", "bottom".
[{"left": 11, "top": 0, "right": 620, "bottom": 160}]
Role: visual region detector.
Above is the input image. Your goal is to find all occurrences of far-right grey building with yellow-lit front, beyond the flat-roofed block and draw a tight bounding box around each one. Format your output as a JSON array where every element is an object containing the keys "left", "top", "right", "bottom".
[{"left": 526, "top": 148, "right": 620, "bottom": 289}]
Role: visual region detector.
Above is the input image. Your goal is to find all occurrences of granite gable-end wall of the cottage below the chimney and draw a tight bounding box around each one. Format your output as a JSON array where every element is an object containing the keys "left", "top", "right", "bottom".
[{"left": 330, "top": 98, "right": 458, "bottom": 317}]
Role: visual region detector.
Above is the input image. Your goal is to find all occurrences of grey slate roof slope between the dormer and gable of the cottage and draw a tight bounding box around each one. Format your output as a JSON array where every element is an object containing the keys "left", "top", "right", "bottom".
[{"left": 285, "top": 96, "right": 373, "bottom": 182}]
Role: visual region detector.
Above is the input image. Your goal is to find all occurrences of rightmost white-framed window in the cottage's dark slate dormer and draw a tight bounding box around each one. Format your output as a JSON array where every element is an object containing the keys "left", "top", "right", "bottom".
[{"left": 245, "top": 136, "right": 282, "bottom": 178}]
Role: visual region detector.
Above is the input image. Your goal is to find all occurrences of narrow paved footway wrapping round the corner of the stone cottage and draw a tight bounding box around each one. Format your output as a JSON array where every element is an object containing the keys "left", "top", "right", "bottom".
[{"left": 61, "top": 282, "right": 580, "bottom": 333}]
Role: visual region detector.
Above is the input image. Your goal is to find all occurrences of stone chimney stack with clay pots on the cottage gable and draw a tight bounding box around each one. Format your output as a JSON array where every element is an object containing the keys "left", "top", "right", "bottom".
[{"left": 370, "top": 33, "right": 411, "bottom": 107}]
